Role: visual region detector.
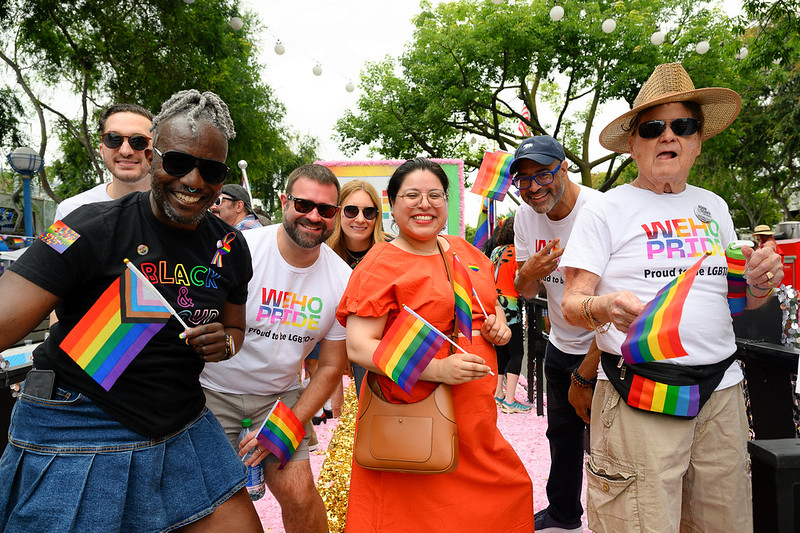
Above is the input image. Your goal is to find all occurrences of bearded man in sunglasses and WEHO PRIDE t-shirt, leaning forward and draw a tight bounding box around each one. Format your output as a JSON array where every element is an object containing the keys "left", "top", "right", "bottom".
[{"left": 200, "top": 165, "right": 351, "bottom": 532}]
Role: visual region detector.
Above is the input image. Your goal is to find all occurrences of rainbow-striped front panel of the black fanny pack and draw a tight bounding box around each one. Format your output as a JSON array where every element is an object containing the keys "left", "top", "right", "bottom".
[{"left": 626, "top": 374, "right": 700, "bottom": 417}]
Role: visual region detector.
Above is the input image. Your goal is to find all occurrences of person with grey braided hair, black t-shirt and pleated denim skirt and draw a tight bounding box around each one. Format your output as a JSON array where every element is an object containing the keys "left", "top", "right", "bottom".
[{"left": 0, "top": 90, "right": 262, "bottom": 531}]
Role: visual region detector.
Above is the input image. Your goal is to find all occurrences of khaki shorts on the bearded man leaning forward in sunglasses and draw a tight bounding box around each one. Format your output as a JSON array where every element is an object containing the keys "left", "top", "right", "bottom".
[{"left": 203, "top": 387, "right": 314, "bottom": 463}]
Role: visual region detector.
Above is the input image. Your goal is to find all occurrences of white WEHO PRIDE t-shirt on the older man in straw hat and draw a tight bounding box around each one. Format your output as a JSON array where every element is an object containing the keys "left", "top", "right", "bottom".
[{"left": 561, "top": 185, "right": 742, "bottom": 389}]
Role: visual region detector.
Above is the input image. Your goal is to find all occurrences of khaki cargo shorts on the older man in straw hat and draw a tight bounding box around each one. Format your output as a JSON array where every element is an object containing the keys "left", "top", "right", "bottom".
[{"left": 586, "top": 380, "right": 753, "bottom": 533}]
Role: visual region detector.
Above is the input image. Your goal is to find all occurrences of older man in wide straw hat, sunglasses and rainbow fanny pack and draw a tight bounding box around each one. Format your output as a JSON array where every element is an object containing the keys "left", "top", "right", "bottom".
[{"left": 561, "top": 63, "right": 783, "bottom": 533}]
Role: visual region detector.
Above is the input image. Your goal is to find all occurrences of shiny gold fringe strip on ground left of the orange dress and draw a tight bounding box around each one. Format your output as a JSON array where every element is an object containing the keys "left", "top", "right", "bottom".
[{"left": 317, "top": 384, "right": 358, "bottom": 533}]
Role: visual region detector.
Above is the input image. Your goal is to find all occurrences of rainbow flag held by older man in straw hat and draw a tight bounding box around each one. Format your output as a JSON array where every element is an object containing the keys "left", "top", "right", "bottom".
[{"left": 622, "top": 252, "right": 710, "bottom": 365}]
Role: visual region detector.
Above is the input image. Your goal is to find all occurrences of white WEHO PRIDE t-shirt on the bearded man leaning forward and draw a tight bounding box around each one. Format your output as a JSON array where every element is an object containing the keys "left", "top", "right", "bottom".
[{"left": 200, "top": 224, "right": 352, "bottom": 396}]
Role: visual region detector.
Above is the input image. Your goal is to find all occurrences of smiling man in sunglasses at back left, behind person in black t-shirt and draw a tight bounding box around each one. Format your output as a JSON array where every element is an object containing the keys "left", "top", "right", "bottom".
[{"left": 55, "top": 104, "right": 153, "bottom": 220}]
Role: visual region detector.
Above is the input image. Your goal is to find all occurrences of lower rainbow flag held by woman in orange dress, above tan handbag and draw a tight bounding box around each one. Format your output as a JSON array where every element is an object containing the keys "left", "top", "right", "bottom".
[{"left": 372, "top": 306, "right": 446, "bottom": 394}]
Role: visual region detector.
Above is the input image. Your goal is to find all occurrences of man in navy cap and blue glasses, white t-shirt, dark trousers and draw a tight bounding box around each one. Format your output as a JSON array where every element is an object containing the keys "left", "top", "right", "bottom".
[{"left": 511, "top": 135, "right": 600, "bottom": 533}]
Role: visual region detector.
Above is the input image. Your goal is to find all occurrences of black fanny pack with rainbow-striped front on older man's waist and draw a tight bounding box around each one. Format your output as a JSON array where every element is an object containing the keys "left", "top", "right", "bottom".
[{"left": 600, "top": 352, "right": 736, "bottom": 419}]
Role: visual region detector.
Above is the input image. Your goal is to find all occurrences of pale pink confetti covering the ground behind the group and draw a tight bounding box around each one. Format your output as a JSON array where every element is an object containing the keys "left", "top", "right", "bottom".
[{"left": 255, "top": 377, "right": 591, "bottom": 533}]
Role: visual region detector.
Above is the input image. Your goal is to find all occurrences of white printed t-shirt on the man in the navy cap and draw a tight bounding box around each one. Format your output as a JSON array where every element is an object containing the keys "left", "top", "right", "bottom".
[{"left": 514, "top": 185, "right": 602, "bottom": 355}]
